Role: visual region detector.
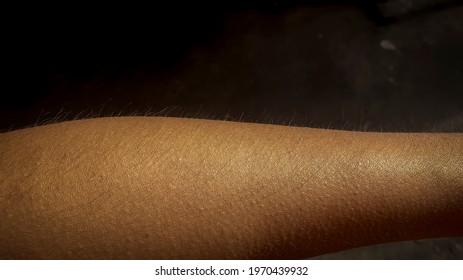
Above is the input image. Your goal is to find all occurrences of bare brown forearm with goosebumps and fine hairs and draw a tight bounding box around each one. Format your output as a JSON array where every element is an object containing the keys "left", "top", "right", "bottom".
[{"left": 0, "top": 117, "right": 463, "bottom": 259}]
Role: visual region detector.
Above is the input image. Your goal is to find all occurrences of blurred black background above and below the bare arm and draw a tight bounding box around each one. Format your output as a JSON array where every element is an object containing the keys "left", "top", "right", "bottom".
[{"left": 0, "top": 0, "right": 463, "bottom": 259}]
